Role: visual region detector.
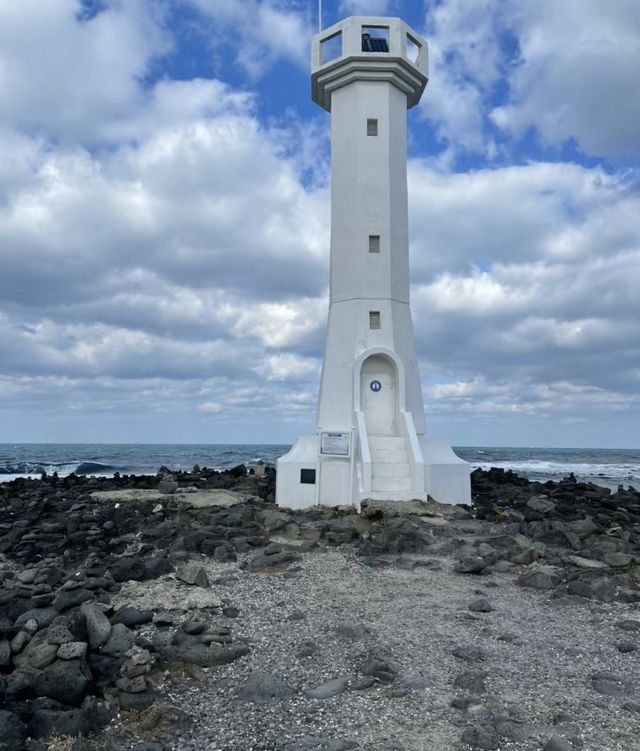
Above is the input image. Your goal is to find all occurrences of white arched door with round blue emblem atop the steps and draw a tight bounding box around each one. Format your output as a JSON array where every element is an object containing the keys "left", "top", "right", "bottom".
[{"left": 360, "top": 355, "right": 396, "bottom": 435}]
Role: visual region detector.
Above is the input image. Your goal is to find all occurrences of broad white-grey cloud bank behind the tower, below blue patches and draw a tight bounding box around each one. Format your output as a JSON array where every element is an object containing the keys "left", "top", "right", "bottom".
[{"left": 0, "top": 119, "right": 640, "bottom": 440}]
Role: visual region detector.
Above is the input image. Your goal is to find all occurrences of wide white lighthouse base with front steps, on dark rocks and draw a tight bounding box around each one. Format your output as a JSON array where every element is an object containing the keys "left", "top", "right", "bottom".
[{"left": 276, "top": 429, "right": 471, "bottom": 510}]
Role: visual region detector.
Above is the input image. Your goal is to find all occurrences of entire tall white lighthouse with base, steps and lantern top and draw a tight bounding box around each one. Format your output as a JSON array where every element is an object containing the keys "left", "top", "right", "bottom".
[{"left": 276, "top": 16, "right": 470, "bottom": 508}]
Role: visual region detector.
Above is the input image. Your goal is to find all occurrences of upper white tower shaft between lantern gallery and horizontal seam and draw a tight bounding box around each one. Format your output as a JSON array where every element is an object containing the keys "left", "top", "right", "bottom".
[{"left": 330, "top": 81, "right": 409, "bottom": 305}]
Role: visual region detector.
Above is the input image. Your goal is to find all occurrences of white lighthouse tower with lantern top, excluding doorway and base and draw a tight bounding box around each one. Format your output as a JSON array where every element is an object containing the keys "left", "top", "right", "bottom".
[{"left": 312, "top": 17, "right": 427, "bottom": 434}]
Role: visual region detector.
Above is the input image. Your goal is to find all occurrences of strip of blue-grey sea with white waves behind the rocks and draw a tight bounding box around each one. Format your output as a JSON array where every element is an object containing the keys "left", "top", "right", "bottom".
[{"left": 0, "top": 443, "right": 640, "bottom": 489}]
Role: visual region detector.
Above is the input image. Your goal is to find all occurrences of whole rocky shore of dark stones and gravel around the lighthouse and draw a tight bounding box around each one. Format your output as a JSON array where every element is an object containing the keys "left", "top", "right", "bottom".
[{"left": 0, "top": 466, "right": 640, "bottom": 751}]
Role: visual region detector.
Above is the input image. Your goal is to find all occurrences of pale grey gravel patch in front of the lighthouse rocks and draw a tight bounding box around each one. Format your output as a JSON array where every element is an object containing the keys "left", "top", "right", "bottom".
[{"left": 114, "top": 548, "right": 640, "bottom": 751}]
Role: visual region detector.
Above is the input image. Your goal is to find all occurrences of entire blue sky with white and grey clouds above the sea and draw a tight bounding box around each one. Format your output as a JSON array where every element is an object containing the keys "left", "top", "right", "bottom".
[{"left": 0, "top": 0, "right": 640, "bottom": 448}]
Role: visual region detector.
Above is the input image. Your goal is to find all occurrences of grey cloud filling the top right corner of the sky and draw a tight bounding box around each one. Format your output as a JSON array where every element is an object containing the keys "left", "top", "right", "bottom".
[{"left": 492, "top": 0, "right": 640, "bottom": 158}]
